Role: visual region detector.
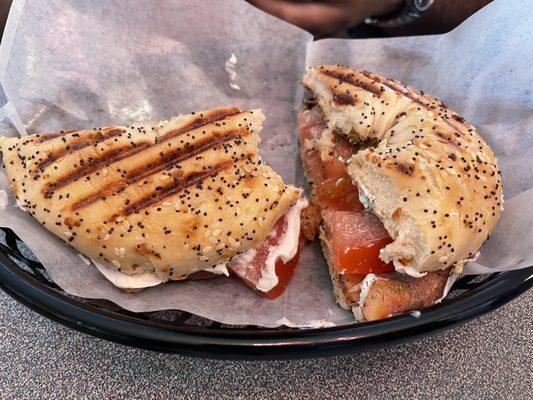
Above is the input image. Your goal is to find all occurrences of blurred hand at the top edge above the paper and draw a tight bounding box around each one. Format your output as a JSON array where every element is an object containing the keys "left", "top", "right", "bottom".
[{"left": 248, "top": 0, "right": 403, "bottom": 36}]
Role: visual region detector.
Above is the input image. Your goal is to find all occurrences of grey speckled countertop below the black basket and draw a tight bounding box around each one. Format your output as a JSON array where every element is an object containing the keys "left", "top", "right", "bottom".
[{"left": 0, "top": 290, "right": 533, "bottom": 400}]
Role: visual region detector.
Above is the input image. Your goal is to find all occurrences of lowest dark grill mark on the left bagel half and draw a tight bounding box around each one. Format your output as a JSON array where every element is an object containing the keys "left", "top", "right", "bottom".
[{"left": 108, "top": 160, "right": 233, "bottom": 222}]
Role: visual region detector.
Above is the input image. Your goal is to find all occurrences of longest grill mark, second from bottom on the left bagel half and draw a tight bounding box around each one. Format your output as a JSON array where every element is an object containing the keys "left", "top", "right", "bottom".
[{"left": 71, "top": 130, "right": 250, "bottom": 211}]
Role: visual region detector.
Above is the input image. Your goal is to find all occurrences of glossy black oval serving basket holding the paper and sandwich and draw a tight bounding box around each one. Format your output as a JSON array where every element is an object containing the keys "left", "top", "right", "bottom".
[{"left": 0, "top": 228, "right": 533, "bottom": 359}]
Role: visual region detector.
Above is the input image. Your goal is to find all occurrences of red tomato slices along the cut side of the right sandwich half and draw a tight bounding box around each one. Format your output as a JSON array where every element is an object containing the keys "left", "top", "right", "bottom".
[{"left": 299, "top": 107, "right": 394, "bottom": 281}]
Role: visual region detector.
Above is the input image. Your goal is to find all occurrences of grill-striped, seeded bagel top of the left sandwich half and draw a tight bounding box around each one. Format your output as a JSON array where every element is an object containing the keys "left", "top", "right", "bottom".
[{"left": 0, "top": 107, "right": 299, "bottom": 279}]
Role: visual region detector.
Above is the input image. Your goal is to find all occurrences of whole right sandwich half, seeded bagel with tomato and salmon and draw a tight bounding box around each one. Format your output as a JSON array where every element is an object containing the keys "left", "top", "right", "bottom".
[{"left": 299, "top": 65, "right": 503, "bottom": 320}]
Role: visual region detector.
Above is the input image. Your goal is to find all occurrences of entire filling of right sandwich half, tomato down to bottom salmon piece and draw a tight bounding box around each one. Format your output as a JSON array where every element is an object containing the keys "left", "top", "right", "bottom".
[{"left": 298, "top": 106, "right": 447, "bottom": 321}]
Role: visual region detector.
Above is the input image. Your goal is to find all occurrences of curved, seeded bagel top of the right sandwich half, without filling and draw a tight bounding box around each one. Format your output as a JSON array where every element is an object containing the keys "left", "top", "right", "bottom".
[{"left": 303, "top": 65, "right": 503, "bottom": 271}]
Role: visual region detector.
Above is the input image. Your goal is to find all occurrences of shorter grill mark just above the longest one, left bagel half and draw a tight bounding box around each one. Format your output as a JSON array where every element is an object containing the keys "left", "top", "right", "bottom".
[{"left": 43, "top": 142, "right": 153, "bottom": 199}]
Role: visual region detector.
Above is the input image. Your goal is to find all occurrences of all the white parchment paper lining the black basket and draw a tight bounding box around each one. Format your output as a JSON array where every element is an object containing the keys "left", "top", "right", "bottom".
[{"left": 0, "top": 0, "right": 533, "bottom": 327}]
